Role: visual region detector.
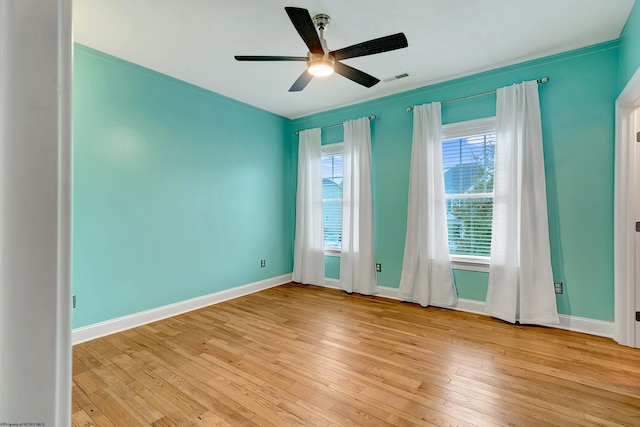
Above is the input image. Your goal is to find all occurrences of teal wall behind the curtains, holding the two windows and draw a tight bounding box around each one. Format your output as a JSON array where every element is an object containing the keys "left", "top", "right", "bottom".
[{"left": 292, "top": 42, "right": 618, "bottom": 320}]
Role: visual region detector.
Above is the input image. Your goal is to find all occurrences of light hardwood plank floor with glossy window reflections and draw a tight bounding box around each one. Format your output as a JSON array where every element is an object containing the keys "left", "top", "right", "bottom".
[{"left": 72, "top": 284, "right": 640, "bottom": 427}]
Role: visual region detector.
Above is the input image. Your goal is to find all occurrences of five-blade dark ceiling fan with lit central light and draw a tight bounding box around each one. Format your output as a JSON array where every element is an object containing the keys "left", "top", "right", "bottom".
[{"left": 235, "top": 7, "right": 408, "bottom": 92}]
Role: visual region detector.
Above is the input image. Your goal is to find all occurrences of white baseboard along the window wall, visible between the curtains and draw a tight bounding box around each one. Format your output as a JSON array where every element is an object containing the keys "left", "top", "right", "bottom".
[{"left": 325, "top": 278, "right": 615, "bottom": 338}]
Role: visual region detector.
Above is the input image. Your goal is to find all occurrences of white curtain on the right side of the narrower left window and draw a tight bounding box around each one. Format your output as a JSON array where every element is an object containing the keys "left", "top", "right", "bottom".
[{"left": 340, "top": 117, "right": 378, "bottom": 295}]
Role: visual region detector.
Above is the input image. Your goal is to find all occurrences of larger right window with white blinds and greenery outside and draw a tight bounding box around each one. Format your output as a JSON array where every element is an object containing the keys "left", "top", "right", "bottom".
[{"left": 442, "top": 117, "right": 496, "bottom": 264}]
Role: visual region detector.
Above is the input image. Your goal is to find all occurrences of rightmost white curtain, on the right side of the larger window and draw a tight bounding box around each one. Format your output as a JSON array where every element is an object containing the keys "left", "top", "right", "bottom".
[{"left": 486, "top": 81, "right": 559, "bottom": 324}]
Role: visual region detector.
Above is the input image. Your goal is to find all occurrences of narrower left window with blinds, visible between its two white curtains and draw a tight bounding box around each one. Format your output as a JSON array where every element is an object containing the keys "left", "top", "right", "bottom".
[{"left": 322, "top": 143, "right": 344, "bottom": 252}]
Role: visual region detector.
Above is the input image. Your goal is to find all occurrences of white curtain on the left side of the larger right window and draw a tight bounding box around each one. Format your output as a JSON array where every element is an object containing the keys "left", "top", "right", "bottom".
[{"left": 399, "top": 102, "right": 458, "bottom": 307}]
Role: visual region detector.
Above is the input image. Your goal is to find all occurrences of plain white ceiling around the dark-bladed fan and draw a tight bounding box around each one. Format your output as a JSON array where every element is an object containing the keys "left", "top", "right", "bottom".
[{"left": 74, "top": 0, "right": 634, "bottom": 118}]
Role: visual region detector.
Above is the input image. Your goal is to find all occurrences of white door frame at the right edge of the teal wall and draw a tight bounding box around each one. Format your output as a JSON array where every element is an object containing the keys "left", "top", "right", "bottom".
[{"left": 614, "top": 68, "right": 640, "bottom": 347}]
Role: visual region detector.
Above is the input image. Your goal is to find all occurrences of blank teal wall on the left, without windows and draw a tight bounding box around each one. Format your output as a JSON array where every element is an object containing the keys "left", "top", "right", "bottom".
[{"left": 73, "top": 45, "right": 295, "bottom": 328}]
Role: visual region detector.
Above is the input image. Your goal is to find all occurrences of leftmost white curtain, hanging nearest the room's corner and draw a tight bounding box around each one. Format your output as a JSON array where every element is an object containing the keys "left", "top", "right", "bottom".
[{"left": 292, "top": 128, "right": 324, "bottom": 285}]
